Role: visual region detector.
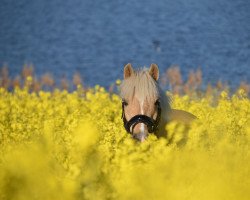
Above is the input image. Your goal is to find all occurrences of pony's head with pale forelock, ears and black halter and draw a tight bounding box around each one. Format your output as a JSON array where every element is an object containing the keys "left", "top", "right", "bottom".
[{"left": 121, "top": 64, "right": 161, "bottom": 141}]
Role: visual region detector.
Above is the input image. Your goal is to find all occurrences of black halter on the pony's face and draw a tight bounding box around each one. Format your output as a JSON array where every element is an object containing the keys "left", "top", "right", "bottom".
[{"left": 122, "top": 101, "right": 161, "bottom": 134}]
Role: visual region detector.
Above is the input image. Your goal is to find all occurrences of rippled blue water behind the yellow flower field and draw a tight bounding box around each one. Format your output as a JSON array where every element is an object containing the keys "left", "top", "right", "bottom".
[{"left": 0, "top": 0, "right": 250, "bottom": 86}]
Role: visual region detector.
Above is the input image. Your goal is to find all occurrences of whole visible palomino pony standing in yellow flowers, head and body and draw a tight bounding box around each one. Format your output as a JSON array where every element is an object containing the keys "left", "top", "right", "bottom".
[{"left": 120, "top": 63, "right": 196, "bottom": 142}]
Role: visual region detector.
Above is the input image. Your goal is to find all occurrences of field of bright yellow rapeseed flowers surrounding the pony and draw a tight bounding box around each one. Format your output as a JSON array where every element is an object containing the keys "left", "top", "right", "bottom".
[{"left": 0, "top": 86, "right": 250, "bottom": 200}]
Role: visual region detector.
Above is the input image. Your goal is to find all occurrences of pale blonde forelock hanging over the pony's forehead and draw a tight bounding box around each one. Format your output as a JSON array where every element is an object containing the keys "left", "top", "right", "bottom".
[{"left": 121, "top": 67, "right": 160, "bottom": 102}]
